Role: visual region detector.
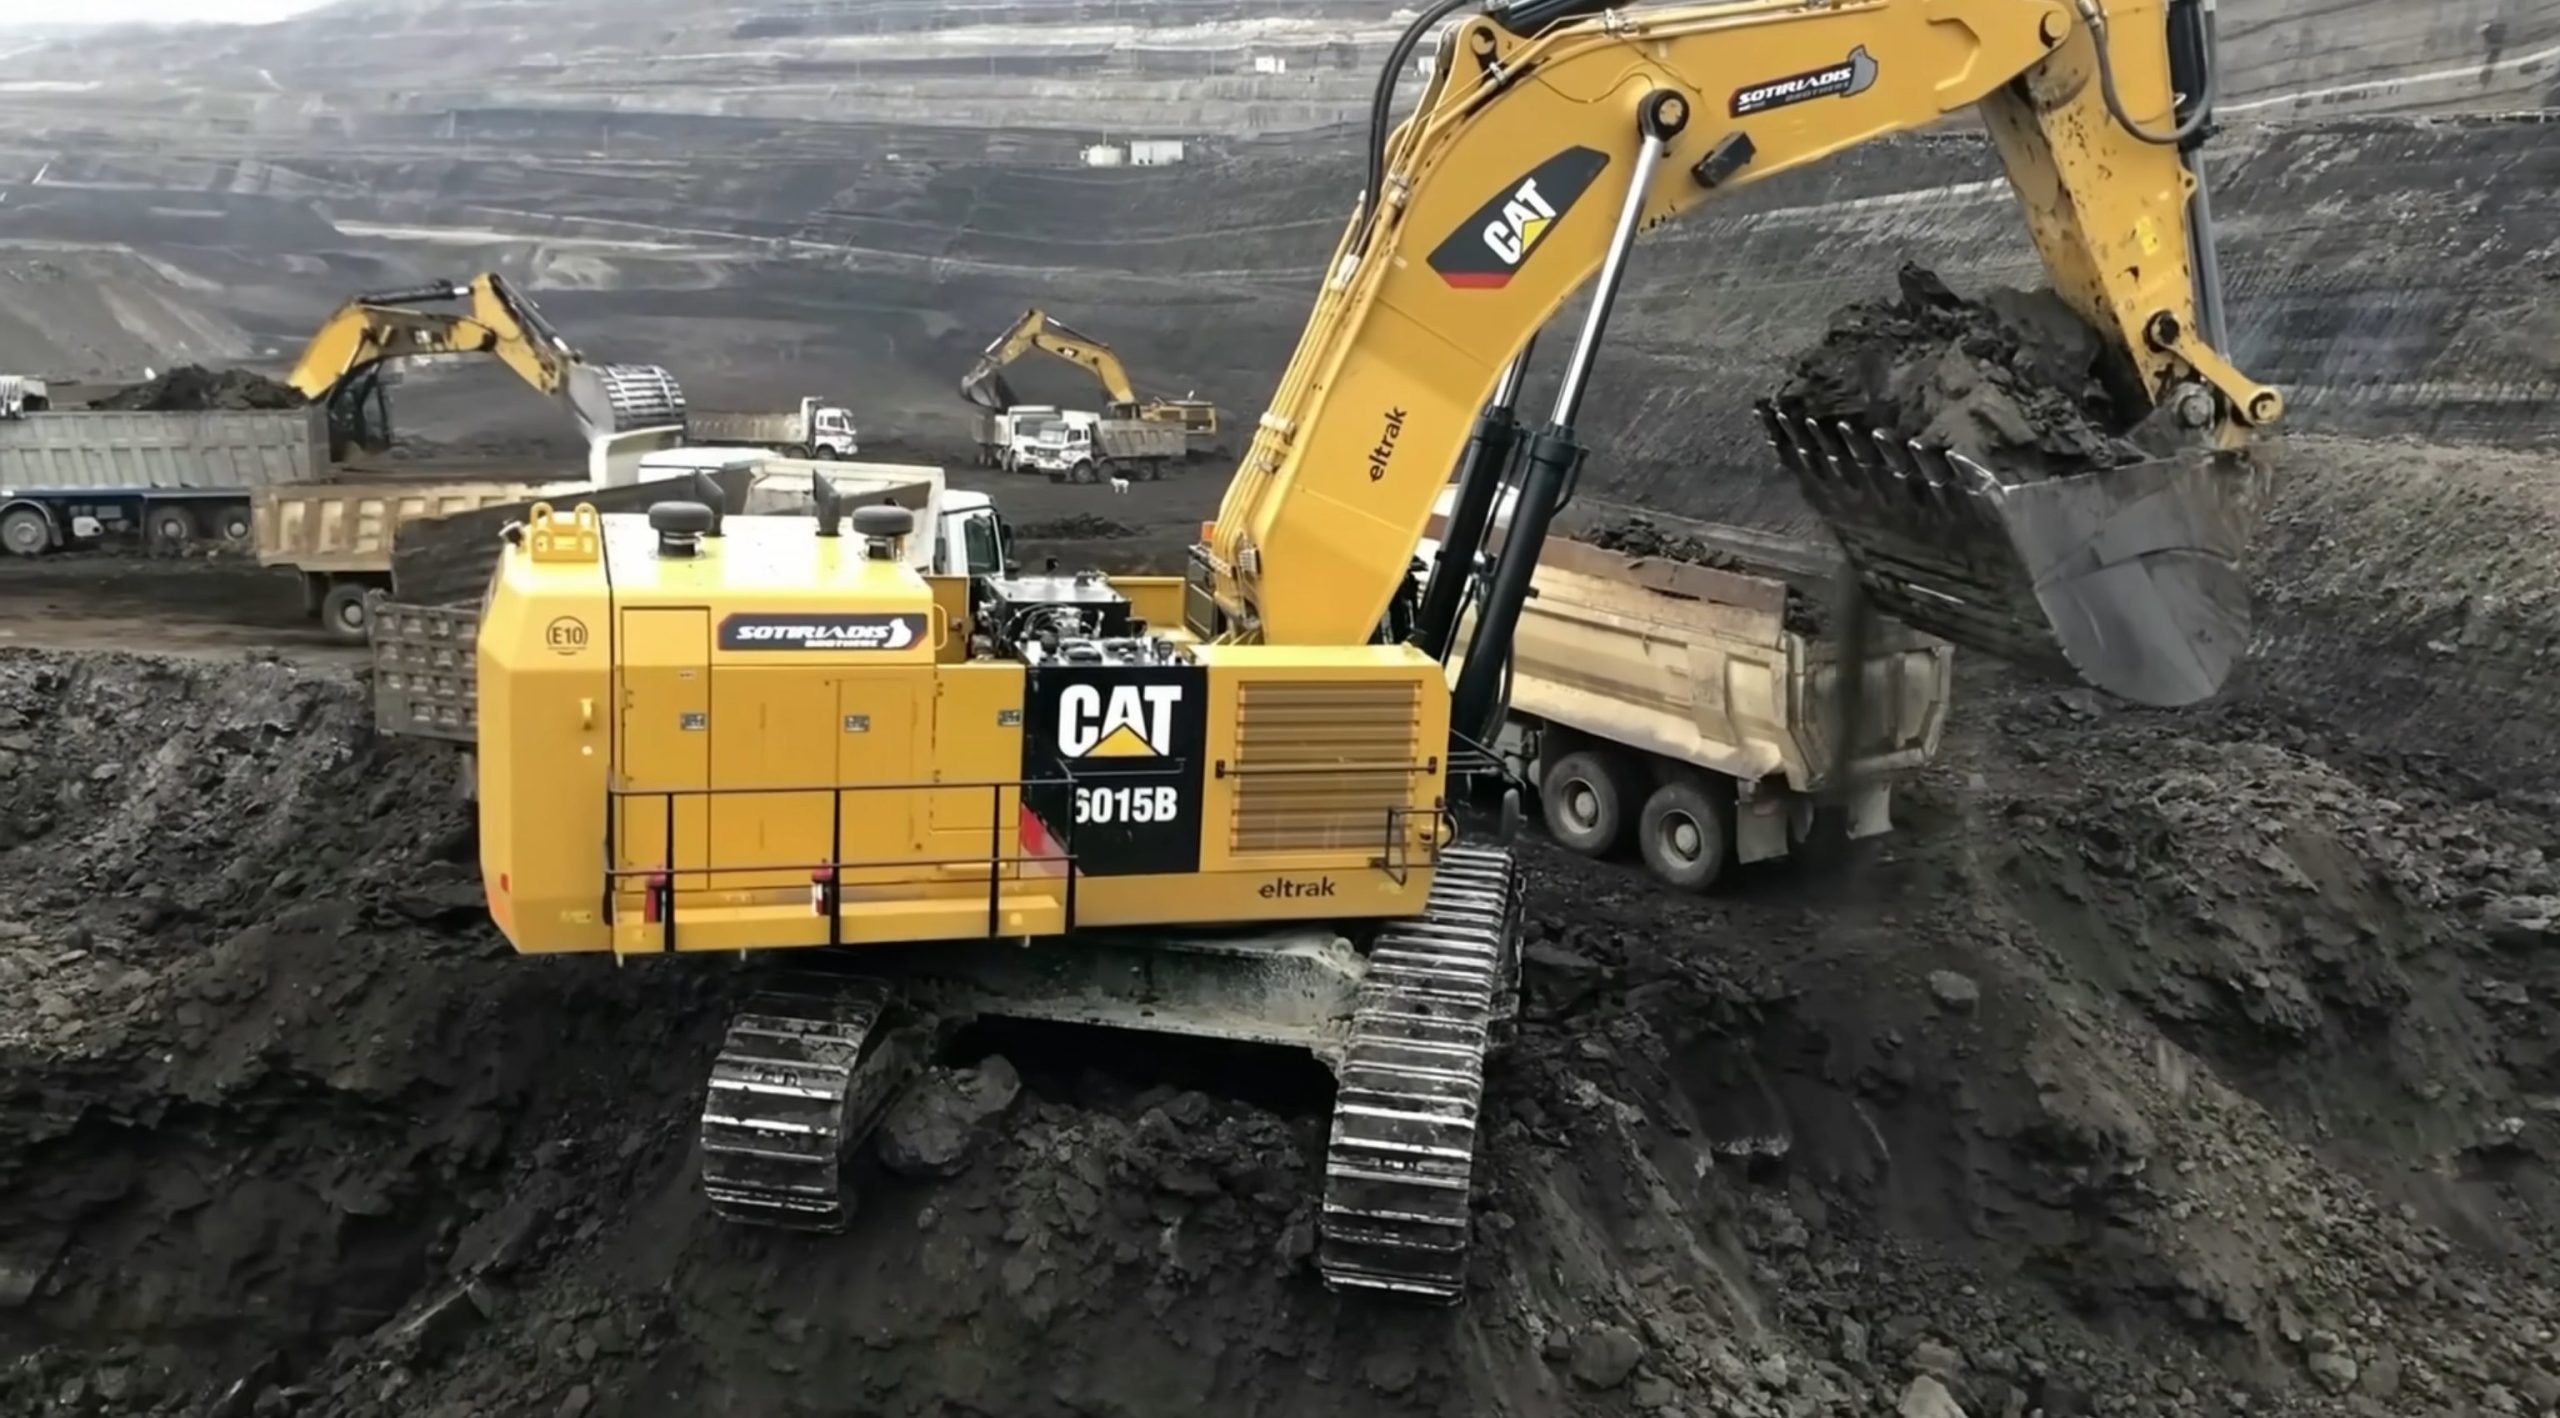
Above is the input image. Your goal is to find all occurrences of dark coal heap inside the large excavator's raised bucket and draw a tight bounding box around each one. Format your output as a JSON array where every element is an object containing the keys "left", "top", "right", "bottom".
[{"left": 1777, "top": 264, "right": 2145, "bottom": 479}]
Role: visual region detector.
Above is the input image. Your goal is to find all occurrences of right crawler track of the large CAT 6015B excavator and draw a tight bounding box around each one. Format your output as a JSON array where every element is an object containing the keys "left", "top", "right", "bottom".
[{"left": 1316, "top": 847, "right": 1521, "bottom": 1303}]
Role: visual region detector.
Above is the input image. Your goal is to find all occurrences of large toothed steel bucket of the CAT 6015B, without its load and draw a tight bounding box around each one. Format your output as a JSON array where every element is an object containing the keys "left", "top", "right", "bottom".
[{"left": 1759, "top": 402, "right": 2266, "bottom": 709}]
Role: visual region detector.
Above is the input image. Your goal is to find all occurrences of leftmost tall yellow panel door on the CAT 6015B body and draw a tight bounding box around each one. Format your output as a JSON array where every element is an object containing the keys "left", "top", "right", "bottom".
[{"left": 614, "top": 598, "right": 712, "bottom": 901}]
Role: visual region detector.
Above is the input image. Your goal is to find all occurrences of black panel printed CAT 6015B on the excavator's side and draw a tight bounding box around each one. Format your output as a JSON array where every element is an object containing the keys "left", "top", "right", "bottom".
[{"left": 1021, "top": 665, "right": 1208, "bottom": 875}]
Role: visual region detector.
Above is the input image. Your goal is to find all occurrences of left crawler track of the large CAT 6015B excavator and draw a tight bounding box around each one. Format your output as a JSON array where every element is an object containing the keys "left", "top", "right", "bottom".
[{"left": 701, "top": 975, "right": 922, "bottom": 1231}]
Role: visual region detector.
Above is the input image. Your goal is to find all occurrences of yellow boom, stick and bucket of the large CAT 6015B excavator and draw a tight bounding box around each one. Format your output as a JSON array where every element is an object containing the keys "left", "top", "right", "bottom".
[{"left": 1190, "top": 0, "right": 2284, "bottom": 706}]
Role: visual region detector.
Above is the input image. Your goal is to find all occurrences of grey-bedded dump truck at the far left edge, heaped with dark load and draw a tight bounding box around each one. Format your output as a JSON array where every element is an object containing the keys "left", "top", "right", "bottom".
[{"left": 0, "top": 399, "right": 330, "bottom": 555}]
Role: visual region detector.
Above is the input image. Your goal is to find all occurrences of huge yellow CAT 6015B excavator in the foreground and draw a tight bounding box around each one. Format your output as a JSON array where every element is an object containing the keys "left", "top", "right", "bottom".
[{"left": 476, "top": 0, "right": 2281, "bottom": 1300}]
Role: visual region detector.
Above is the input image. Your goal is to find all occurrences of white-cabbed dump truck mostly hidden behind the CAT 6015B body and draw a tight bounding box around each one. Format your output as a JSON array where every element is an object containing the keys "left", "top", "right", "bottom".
[{"left": 364, "top": 458, "right": 1011, "bottom": 752}]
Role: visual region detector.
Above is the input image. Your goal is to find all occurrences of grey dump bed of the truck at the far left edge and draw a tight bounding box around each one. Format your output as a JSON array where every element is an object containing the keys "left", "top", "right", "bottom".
[{"left": 0, "top": 407, "right": 328, "bottom": 494}]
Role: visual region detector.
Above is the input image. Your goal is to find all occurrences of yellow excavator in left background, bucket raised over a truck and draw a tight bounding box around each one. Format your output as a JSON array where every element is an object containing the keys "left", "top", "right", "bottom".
[{"left": 287, "top": 271, "right": 684, "bottom": 456}]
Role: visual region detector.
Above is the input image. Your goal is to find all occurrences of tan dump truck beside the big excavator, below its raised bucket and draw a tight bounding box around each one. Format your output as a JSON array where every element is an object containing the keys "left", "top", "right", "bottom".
[{"left": 1421, "top": 494, "right": 1956, "bottom": 891}]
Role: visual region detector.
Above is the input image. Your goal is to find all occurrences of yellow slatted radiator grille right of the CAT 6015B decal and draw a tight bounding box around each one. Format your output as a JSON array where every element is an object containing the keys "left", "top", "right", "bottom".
[{"left": 1229, "top": 678, "right": 1426, "bottom": 852}]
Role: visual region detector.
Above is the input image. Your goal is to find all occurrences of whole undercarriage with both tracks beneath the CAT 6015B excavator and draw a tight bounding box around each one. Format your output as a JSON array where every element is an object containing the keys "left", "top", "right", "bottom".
[{"left": 701, "top": 847, "right": 1521, "bottom": 1300}]
